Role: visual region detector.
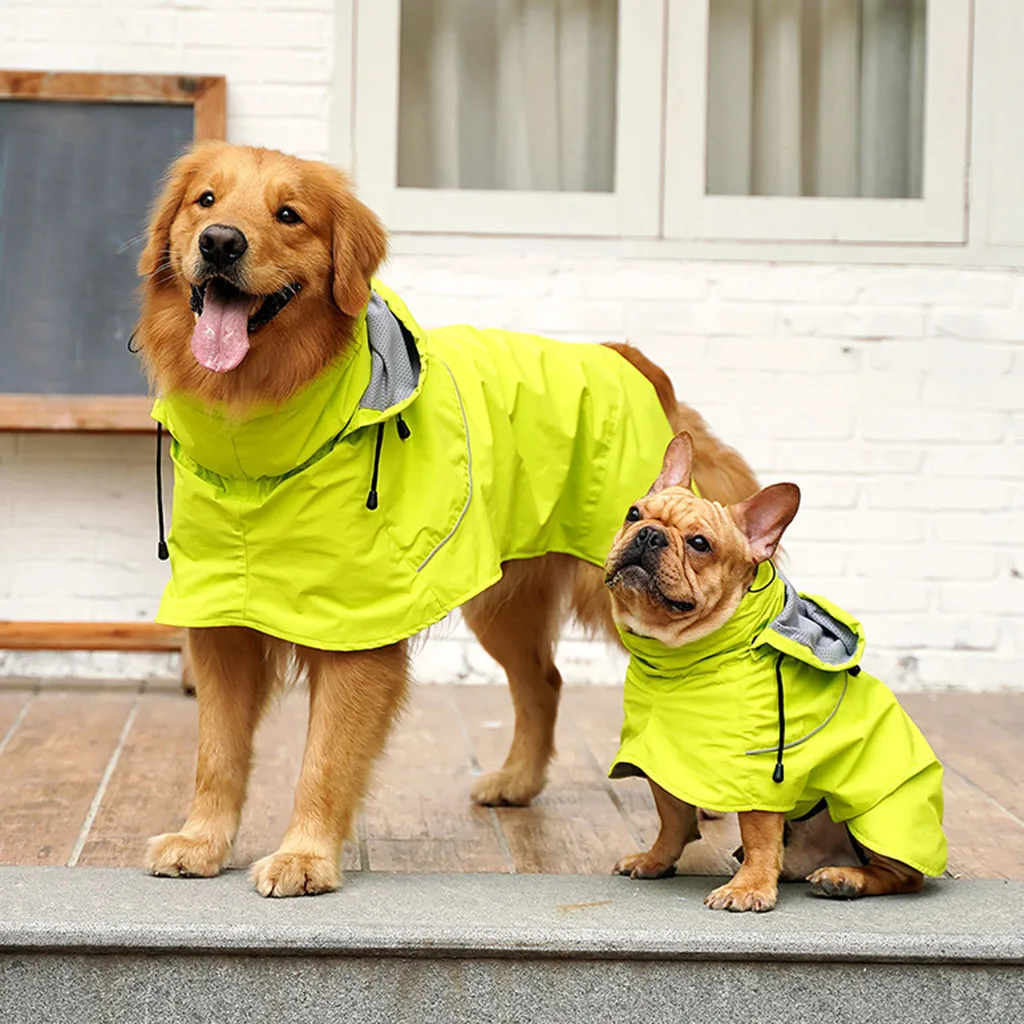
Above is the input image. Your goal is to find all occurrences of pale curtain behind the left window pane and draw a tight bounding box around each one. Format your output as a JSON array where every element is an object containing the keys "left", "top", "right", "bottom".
[{"left": 398, "top": 0, "right": 617, "bottom": 191}]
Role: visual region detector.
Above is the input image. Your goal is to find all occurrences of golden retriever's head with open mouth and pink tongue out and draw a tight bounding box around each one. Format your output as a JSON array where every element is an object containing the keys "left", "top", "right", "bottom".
[{"left": 138, "top": 142, "right": 387, "bottom": 400}]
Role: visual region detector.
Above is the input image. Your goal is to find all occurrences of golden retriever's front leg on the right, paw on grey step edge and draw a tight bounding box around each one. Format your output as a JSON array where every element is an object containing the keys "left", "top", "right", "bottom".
[{"left": 250, "top": 643, "right": 409, "bottom": 896}]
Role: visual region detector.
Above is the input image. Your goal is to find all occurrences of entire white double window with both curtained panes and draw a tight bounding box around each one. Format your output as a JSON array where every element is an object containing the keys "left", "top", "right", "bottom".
[{"left": 353, "top": 0, "right": 972, "bottom": 243}]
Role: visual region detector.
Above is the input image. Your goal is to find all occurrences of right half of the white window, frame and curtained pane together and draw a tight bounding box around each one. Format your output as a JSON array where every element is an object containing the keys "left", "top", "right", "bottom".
[{"left": 665, "top": 0, "right": 971, "bottom": 243}]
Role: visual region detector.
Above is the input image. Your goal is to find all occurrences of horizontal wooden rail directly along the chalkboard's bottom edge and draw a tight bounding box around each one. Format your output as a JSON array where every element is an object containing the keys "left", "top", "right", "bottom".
[{"left": 0, "top": 394, "right": 157, "bottom": 434}]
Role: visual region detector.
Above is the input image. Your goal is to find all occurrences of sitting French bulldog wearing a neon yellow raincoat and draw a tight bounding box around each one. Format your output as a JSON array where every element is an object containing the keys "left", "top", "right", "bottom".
[{"left": 605, "top": 432, "right": 946, "bottom": 911}]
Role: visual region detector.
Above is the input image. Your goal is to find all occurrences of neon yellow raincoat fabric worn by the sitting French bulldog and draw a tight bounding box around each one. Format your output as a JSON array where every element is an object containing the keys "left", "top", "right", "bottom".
[{"left": 609, "top": 566, "right": 946, "bottom": 876}]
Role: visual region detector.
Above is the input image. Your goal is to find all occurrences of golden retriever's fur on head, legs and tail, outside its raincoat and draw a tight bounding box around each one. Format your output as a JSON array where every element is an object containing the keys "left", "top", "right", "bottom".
[{"left": 137, "top": 142, "right": 757, "bottom": 896}]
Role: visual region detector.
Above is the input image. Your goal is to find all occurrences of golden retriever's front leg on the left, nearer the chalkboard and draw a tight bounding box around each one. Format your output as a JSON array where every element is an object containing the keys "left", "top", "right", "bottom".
[{"left": 145, "top": 627, "right": 274, "bottom": 878}]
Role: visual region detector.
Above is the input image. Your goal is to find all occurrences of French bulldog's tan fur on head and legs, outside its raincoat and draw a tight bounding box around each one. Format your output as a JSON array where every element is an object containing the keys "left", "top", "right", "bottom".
[{"left": 605, "top": 433, "right": 924, "bottom": 911}]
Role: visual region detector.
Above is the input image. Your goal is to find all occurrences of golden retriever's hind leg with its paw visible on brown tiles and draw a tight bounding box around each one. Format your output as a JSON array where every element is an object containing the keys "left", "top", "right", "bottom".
[{"left": 463, "top": 555, "right": 574, "bottom": 807}]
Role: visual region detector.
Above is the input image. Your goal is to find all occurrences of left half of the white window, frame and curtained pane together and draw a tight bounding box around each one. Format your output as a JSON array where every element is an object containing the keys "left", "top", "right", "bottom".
[{"left": 354, "top": 0, "right": 664, "bottom": 238}]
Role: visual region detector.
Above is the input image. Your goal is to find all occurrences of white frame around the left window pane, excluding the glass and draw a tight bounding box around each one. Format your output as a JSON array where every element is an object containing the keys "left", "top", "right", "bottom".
[{"left": 352, "top": 0, "right": 663, "bottom": 238}]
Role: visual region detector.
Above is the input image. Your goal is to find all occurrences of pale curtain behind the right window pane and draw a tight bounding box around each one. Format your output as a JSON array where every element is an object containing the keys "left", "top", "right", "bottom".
[{"left": 707, "top": 0, "right": 927, "bottom": 198}]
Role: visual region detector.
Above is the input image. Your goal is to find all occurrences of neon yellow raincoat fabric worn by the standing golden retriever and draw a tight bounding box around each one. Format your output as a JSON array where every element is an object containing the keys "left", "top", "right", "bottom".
[{"left": 153, "top": 282, "right": 672, "bottom": 650}]
